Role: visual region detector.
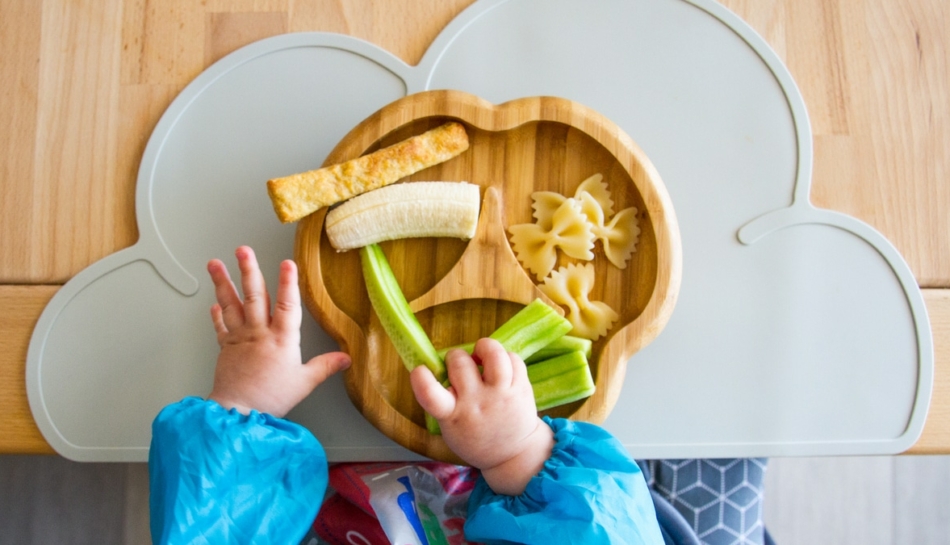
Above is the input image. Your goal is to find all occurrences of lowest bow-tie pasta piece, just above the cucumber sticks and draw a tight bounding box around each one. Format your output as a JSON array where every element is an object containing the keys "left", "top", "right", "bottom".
[{"left": 538, "top": 263, "right": 620, "bottom": 341}]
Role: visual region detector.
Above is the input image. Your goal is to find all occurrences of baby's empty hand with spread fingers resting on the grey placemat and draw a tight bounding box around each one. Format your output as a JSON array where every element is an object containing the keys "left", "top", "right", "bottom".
[{"left": 208, "top": 246, "right": 350, "bottom": 417}]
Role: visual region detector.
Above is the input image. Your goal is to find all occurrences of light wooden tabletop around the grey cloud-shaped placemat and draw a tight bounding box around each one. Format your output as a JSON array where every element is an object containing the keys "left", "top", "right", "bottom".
[{"left": 0, "top": 0, "right": 950, "bottom": 453}]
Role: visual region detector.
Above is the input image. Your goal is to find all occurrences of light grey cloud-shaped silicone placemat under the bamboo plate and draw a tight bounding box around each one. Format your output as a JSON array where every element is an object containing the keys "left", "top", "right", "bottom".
[{"left": 27, "top": 0, "right": 933, "bottom": 461}]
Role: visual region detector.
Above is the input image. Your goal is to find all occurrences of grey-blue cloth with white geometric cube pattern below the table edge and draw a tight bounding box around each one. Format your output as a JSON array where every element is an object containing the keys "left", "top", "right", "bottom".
[{"left": 641, "top": 458, "right": 772, "bottom": 545}]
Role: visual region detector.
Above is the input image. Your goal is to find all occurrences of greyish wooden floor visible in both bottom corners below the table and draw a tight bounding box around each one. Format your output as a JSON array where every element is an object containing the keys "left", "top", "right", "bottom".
[{"left": 0, "top": 456, "right": 950, "bottom": 545}]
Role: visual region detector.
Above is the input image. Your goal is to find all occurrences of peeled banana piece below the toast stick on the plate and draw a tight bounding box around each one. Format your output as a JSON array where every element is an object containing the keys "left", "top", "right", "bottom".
[{"left": 324, "top": 182, "right": 481, "bottom": 252}]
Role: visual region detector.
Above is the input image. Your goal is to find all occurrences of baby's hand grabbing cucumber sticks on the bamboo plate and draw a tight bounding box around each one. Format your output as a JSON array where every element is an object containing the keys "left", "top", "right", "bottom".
[{"left": 410, "top": 339, "right": 554, "bottom": 496}]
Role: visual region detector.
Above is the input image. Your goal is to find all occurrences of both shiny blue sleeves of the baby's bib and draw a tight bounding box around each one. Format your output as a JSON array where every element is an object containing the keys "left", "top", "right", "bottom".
[{"left": 149, "top": 397, "right": 663, "bottom": 545}]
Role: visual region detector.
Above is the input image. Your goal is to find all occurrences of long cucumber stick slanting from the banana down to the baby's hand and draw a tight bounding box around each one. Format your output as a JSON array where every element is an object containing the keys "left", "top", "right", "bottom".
[{"left": 360, "top": 244, "right": 446, "bottom": 381}]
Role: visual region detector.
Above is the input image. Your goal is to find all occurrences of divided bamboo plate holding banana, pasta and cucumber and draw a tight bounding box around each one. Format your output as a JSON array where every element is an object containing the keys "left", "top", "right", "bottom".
[{"left": 295, "top": 91, "right": 682, "bottom": 463}]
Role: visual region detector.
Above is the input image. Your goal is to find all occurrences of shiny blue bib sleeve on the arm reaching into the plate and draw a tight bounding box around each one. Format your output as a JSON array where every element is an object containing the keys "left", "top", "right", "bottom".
[{"left": 465, "top": 417, "right": 663, "bottom": 545}]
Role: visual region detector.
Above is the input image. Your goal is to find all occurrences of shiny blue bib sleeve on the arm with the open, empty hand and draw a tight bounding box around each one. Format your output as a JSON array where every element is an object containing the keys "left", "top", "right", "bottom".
[{"left": 148, "top": 397, "right": 328, "bottom": 545}]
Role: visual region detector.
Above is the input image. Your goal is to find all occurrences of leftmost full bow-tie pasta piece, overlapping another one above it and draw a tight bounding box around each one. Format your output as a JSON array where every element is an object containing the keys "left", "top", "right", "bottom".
[{"left": 508, "top": 199, "right": 594, "bottom": 278}]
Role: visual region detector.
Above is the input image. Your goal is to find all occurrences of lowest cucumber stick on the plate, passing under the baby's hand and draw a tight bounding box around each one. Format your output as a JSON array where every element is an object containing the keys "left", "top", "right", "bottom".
[{"left": 426, "top": 351, "right": 597, "bottom": 435}]
